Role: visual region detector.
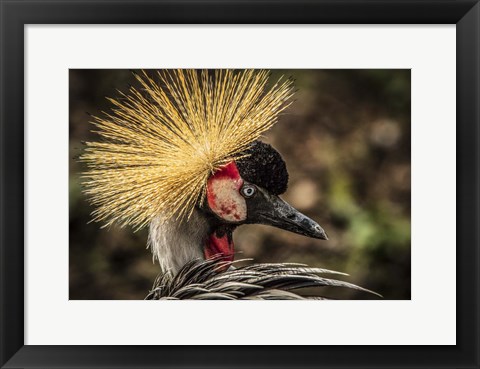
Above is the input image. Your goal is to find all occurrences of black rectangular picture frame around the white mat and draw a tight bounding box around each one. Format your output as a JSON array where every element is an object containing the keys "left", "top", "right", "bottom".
[{"left": 0, "top": 0, "right": 480, "bottom": 368}]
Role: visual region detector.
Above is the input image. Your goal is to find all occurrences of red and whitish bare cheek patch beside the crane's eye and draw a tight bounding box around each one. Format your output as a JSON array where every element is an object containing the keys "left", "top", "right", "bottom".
[{"left": 207, "top": 161, "right": 247, "bottom": 222}]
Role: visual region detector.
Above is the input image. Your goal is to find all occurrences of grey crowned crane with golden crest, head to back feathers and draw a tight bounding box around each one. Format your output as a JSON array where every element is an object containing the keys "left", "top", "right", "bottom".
[{"left": 80, "top": 69, "right": 378, "bottom": 299}]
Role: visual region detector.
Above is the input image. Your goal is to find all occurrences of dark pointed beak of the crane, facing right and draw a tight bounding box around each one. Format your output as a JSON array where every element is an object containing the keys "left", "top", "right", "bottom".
[{"left": 247, "top": 191, "right": 328, "bottom": 240}]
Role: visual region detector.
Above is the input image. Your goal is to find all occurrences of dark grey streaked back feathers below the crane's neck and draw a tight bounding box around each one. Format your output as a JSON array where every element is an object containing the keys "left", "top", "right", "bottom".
[{"left": 146, "top": 256, "right": 377, "bottom": 300}]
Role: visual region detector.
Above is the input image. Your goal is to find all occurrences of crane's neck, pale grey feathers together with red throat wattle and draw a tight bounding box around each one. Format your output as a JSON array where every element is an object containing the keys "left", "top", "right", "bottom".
[{"left": 148, "top": 209, "right": 234, "bottom": 275}]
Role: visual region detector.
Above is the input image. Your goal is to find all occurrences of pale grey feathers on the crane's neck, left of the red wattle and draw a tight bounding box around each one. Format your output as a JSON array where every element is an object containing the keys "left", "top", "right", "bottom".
[{"left": 147, "top": 209, "right": 211, "bottom": 275}]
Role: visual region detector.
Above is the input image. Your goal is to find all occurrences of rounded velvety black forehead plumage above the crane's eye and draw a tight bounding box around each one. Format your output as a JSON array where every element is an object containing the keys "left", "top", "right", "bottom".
[{"left": 236, "top": 141, "right": 288, "bottom": 195}]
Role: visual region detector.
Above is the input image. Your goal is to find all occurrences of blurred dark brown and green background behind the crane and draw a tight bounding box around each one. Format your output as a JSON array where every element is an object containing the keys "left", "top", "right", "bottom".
[{"left": 69, "top": 69, "right": 411, "bottom": 299}]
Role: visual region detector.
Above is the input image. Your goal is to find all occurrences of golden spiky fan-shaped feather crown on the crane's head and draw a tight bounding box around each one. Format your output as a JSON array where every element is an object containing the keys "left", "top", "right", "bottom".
[{"left": 80, "top": 69, "right": 293, "bottom": 229}]
